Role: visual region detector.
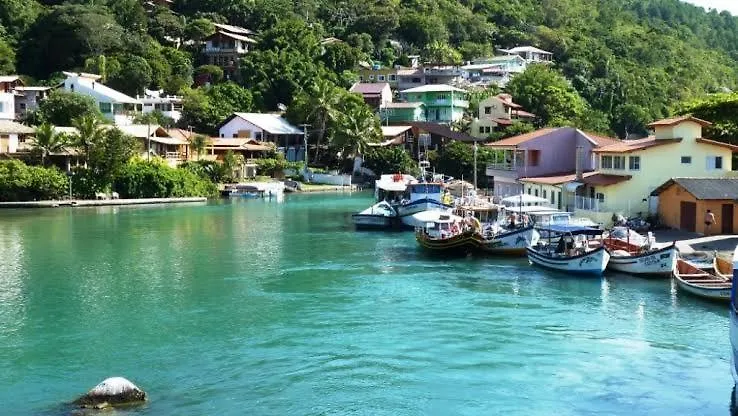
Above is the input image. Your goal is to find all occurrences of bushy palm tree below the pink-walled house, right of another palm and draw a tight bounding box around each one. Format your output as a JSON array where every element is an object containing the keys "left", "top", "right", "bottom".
[{"left": 333, "top": 108, "right": 382, "bottom": 172}]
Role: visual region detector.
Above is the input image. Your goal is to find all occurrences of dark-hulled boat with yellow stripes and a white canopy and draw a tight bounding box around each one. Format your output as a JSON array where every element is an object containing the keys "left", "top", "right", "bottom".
[{"left": 414, "top": 211, "right": 481, "bottom": 254}]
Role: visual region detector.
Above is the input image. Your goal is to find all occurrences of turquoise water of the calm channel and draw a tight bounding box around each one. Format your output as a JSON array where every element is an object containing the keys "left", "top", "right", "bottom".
[{"left": 0, "top": 194, "right": 733, "bottom": 416}]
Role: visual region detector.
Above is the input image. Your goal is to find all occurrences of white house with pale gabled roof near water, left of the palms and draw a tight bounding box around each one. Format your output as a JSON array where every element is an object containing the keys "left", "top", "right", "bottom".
[{"left": 218, "top": 113, "right": 305, "bottom": 162}]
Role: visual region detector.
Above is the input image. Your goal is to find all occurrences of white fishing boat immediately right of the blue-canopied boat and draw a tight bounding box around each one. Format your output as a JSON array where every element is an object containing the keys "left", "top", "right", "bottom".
[{"left": 603, "top": 227, "right": 679, "bottom": 276}]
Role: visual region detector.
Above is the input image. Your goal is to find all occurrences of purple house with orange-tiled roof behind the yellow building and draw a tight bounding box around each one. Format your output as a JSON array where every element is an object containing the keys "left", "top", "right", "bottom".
[{"left": 485, "top": 127, "right": 619, "bottom": 197}]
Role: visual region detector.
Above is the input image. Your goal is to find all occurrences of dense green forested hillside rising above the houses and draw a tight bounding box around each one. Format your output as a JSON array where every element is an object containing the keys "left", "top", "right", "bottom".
[{"left": 0, "top": 0, "right": 738, "bottom": 135}]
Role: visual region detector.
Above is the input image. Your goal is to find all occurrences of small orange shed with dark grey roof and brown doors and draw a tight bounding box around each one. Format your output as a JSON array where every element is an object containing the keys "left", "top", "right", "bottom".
[{"left": 651, "top": 178, "right": 738, "bottom": 234}]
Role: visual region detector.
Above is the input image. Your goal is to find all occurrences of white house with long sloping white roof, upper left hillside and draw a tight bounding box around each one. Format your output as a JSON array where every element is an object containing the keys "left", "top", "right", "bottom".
[{"left": 64, "top": 72, "right": 142, "bottom": 125}]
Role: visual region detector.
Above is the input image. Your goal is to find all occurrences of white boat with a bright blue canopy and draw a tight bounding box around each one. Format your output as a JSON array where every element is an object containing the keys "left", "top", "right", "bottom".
[{"left": 526, "top": 224, "right": 610, "bottom": 276}]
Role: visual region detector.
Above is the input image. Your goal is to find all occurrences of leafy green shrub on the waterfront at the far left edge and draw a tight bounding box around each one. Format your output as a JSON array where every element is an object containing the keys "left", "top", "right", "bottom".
[{"left": 0, "top": 160, "right": 69, "bottom": 201}]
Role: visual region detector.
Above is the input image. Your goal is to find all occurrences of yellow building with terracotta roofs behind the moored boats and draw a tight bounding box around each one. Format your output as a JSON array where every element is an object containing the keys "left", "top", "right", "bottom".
[{"left": 521, "top": 116, "right": 738, "bottom": 224}]
